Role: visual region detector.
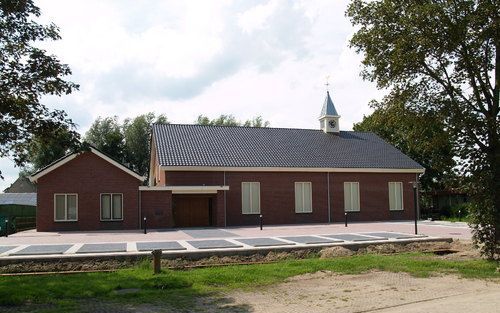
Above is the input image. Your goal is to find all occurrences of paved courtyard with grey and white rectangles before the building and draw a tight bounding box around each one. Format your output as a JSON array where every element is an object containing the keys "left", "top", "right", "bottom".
[{"left": 0, "top": 221, "right": 471, "bottom": 259}]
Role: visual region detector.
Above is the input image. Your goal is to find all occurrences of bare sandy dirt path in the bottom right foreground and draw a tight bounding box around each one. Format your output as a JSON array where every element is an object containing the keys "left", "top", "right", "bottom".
[{"left": 227, "top": 272, "right": 500, "bottom": 313}]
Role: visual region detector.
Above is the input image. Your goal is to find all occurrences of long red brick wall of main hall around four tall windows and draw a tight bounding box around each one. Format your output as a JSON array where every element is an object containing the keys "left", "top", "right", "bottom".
[{"left": 166, "top": 172, "right": 415, "bottom": 226}]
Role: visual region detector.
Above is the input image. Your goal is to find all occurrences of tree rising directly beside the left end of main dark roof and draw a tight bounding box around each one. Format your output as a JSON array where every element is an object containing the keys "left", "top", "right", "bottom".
[{"left": 122, "top": 112, "right": 168, "bottom": 176}]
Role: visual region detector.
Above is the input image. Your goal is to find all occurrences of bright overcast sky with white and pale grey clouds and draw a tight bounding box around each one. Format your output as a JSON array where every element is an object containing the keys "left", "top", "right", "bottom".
[{"left": 0, "top": 0, "right": 383, "bottom": 190}]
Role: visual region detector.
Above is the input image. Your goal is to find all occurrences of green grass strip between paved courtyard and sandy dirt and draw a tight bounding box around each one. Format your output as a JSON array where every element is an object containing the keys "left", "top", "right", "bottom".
[{"left": 0, "top": 253, "right": 500, "bottom": 312}]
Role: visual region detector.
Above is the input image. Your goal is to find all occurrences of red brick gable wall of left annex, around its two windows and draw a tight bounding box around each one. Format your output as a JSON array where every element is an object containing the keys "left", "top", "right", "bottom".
[{"left": 37, "top": 152, "right": 141, "bottom": 231}]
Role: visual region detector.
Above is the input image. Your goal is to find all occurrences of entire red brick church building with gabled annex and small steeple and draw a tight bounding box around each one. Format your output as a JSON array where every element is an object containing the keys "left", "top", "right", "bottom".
[{"left": 31, "top": 93, "right": 424, "bottom": 231}]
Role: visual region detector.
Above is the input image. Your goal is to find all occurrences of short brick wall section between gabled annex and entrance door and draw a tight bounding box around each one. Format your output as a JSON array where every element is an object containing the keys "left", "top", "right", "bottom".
[{"left": 141, "top": 190, "right": 173, "bottom": 228}]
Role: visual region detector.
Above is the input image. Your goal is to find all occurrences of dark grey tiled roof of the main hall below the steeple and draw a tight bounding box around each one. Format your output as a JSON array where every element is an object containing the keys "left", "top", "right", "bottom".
[{"left": 153, "top": 124, "right": 422, "bottom": 169}]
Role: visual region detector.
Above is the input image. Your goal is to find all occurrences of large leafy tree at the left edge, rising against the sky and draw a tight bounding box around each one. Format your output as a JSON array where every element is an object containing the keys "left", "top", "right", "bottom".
[{"left": 0, "top": 0, "right": 79, "bottom": 177}]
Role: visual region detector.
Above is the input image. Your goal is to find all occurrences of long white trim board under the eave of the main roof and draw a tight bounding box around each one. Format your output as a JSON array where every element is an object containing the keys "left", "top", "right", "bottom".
[{"left": 160, "top": 166, "right": 425, "bottom": 174}]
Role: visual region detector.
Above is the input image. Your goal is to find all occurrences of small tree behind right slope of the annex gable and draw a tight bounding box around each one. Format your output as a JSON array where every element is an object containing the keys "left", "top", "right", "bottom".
[{"left": 85, "top": 116, "right": 125, "bottom": 162}]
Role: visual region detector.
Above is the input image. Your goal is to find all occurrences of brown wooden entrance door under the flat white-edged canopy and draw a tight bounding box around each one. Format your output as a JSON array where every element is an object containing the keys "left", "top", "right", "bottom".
[{"left": 173, "top": 195, "right": 211, "bottom": 227}]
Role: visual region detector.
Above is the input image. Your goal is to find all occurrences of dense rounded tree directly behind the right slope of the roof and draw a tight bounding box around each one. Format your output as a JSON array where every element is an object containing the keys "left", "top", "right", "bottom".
[{"left": 353, "top": 91, "right": 455, "bottom": 191}]
